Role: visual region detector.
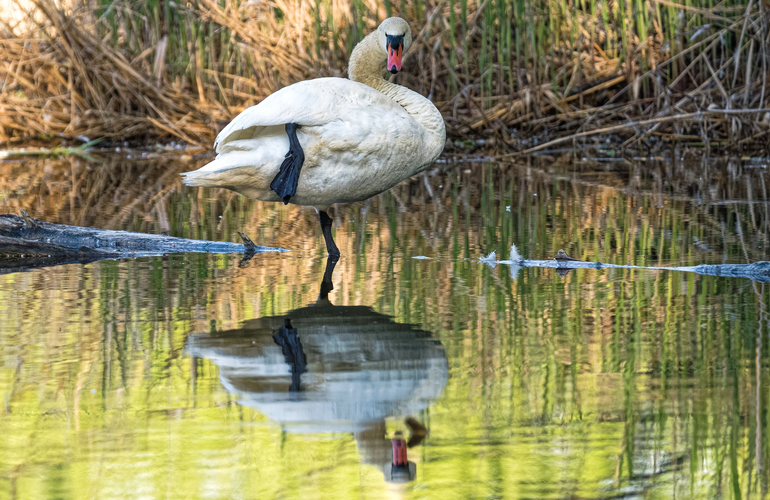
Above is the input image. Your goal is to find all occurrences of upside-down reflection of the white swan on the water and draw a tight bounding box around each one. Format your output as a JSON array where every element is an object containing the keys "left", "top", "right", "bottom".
[{"left": 188, "top": 259, "right": 448, "bottom": 482}]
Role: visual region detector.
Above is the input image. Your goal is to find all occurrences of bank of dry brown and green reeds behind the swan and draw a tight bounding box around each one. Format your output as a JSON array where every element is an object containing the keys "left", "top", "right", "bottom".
[{"left": 0, "top": 0, "right": 770, "bottom": 152}]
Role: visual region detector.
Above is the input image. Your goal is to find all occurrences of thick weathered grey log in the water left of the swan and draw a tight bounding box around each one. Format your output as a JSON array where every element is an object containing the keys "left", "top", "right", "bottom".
[{"left": 0, "top": 211, "right": 287, "bottom": 273}]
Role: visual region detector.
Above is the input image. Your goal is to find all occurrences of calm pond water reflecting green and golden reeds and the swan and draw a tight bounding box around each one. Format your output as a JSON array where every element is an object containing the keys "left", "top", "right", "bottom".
[{"left": 0, "top": 153, "right": 770, "bottom": 499}]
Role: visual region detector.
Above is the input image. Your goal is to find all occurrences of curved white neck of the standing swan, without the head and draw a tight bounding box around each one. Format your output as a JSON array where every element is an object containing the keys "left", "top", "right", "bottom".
[{"left": 348, "top": 31, "right": 446, "bottom": 166}]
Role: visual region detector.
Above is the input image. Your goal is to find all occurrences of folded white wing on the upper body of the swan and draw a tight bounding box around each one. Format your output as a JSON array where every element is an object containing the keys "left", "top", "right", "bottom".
[{"left": 214, "top": 78, "right": 402, "bottom": 153}]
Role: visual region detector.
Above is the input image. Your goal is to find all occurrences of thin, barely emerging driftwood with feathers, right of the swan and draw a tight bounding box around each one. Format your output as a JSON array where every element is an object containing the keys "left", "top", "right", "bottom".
[{"left": 479, "top": 245, "right": 770, "bottom": 283}]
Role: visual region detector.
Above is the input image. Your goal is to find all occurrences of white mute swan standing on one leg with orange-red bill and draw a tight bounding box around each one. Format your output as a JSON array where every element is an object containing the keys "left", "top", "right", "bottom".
[{"left": 182, "top": 17, "right": 446, "bottom": 256}]
